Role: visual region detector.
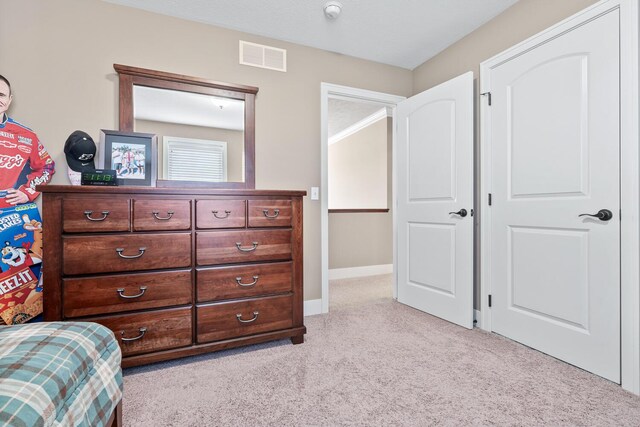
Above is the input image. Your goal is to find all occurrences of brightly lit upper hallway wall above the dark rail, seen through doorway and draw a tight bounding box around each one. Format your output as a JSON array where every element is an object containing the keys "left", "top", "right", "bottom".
[{"left": 328, "top": 119, "right": 387, "bottom": 209}]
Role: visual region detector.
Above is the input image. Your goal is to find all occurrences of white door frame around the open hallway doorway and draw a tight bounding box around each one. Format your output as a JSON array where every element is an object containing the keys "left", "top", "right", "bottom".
[{"left": 320, "top": 82, "right": 406, "bottom": 313}]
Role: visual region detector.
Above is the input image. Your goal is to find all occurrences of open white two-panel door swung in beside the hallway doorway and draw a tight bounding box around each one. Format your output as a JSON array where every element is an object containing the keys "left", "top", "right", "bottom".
[{"left": 396, "top": 72, "right": 473, "bottom": 328}]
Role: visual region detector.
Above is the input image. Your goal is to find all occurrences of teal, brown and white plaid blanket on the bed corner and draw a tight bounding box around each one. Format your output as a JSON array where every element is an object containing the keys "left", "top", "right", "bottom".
[{"left": 0, "top": 322, "right": 122, "bottom": 427}]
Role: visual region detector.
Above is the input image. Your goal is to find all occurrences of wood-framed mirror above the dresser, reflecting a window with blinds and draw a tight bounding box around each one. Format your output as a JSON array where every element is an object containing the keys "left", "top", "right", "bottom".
[{"left": 113, "top": 64, "right": 258, "bottom": 188}]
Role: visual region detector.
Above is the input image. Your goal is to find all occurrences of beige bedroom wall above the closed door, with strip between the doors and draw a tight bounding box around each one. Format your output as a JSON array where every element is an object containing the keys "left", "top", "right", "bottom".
[{"left": 413, "top": 0, "right": 597, "bottom": 308}]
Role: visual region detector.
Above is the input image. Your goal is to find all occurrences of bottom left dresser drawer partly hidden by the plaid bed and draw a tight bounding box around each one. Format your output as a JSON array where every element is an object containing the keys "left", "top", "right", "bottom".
[{"left": 91, "top": 307, "right": 193, "bottom": 357}]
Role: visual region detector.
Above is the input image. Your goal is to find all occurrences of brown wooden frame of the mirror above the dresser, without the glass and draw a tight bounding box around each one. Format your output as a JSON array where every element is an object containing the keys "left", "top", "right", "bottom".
[{"left": 113, "top": 64, "right": 258, "bottom": 188}]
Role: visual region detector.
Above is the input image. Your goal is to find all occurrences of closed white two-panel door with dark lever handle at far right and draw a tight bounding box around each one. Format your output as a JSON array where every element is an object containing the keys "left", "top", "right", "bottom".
[{"left": 485, "top": 9, "right": 620, "bottom": 382}]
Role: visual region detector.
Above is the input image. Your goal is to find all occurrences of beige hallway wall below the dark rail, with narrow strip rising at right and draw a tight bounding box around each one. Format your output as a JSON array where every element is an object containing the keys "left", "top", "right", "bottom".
[{"left": 329, "top": 118, "right": 393, "bottom": 269}]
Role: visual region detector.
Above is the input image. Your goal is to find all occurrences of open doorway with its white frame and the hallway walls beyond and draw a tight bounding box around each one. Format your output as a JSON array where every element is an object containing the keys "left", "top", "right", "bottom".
[{"left": 321, "top": 83, "right": 404, "bottom": 313}]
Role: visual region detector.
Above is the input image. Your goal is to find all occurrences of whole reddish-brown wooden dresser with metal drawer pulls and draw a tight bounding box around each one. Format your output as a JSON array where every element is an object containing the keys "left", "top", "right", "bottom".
[{"left": 39, "top": 185, "right": 306, "bottom": 367}]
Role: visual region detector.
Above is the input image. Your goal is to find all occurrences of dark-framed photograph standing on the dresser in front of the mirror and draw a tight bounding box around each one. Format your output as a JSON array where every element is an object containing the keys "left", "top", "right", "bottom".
[{"left": 100, "top": 129, "right": 158, "bottom": 187}]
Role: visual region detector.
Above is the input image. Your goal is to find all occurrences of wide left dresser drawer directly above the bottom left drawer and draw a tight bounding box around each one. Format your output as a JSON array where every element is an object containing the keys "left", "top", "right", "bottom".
[{"left": 63, "top": 271, "right": 192, "bottom": 317}]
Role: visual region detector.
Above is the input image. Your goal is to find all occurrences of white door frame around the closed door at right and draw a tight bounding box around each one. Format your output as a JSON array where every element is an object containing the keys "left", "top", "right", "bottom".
[{"left": 479, "top": 0, "right": 640, "bottom": 394}]
